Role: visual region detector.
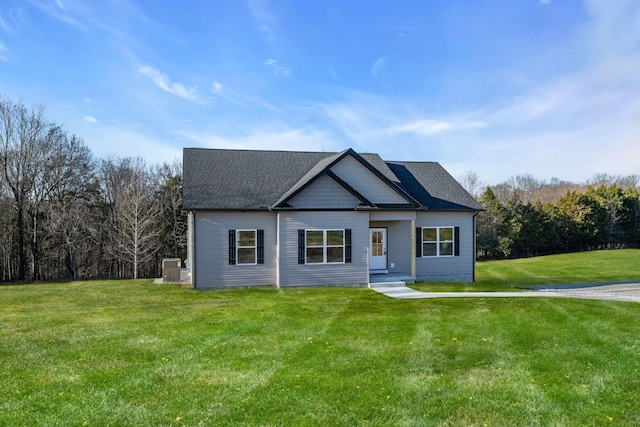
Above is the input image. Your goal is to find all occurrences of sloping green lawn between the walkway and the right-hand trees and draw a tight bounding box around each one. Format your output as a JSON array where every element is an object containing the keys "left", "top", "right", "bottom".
[{"left": 412, "top": 249, "right": 640, "bottom": 292}]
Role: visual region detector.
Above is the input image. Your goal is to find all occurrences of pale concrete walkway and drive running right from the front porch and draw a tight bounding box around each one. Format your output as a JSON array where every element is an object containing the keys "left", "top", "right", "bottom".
[{"left": 370, "top": 282, "right": 640, "bottom": 303}]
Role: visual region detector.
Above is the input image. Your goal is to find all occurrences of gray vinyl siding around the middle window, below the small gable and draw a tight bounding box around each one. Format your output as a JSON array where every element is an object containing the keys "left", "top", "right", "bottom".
[{"left": 280, "top": 211, "right": 369, "bottom": 287}]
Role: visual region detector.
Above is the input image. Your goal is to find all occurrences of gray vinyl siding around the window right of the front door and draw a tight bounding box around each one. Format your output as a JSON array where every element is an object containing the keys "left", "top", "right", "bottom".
[{"left": 416, "top": 212, "right": 475, "bottom": 282}]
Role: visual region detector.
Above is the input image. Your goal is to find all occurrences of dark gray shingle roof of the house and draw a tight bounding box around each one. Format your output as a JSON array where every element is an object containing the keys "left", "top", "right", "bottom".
[{"left": 183, "top": 148, "right": 482, "bottom": 210}]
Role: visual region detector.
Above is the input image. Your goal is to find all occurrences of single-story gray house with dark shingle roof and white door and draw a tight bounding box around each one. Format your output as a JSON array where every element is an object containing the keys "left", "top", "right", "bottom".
[{"left": 183, "top": 148, "right": 482, "bottom": 289}]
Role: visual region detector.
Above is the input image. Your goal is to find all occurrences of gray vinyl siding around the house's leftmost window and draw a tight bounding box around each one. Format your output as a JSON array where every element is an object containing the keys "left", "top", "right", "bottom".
[{"left": 193, "top": 211, "right": 276, "bottom": 289}]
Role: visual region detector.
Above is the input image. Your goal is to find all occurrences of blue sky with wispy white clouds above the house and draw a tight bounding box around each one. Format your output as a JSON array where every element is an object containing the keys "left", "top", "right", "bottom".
[{"left": 0, "top": 0, "right": 640, "bottom": 183}]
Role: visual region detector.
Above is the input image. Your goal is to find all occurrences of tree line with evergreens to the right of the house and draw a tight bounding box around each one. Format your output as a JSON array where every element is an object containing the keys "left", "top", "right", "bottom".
[{"left": 460, "top": 172, "right": 640, "bottom": 259}]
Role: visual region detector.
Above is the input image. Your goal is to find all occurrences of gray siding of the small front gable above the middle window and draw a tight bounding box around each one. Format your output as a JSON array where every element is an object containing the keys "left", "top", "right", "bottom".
[{"left": 289, "top": 175, "right": 360, "bottom": 208}]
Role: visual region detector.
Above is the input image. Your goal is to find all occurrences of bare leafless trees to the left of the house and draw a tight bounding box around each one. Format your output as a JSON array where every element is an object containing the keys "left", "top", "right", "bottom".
[{"left": 0, "top": 96, "right": 187, "bottom": 282}]
